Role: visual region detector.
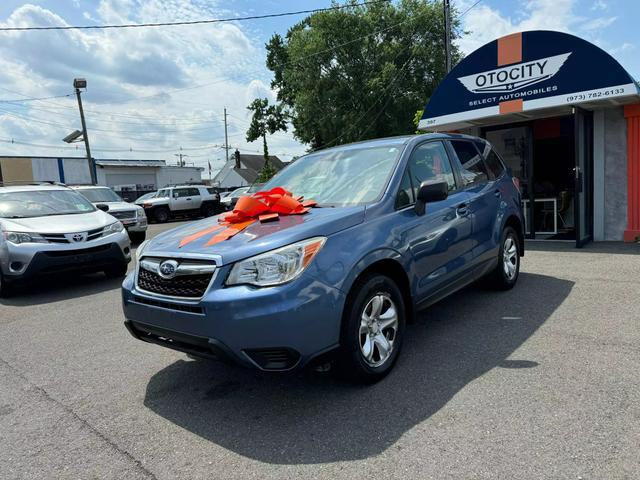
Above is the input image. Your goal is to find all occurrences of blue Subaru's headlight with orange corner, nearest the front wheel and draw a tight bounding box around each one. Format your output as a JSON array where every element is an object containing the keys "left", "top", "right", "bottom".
[{"left": 227, "top": 237, "right": 327, "bottom": 287}]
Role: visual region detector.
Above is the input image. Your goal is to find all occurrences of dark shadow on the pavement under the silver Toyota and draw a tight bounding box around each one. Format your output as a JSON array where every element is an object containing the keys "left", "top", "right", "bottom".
[{"left": 0, "top": 273, "right": 124, "bottom": 307}]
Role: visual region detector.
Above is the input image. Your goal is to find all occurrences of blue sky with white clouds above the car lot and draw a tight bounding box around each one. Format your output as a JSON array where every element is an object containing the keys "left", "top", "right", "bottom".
[{"left": 0, "top": 0, "right": 640, "bottom": 177}]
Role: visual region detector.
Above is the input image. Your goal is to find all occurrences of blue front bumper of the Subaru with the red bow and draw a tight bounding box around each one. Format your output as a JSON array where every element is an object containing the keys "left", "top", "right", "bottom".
[{"left": 122, "top": 267, "right": 345, "bottom": 371}]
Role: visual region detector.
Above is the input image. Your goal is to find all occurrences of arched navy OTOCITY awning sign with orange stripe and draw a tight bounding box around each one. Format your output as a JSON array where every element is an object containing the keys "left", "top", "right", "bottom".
[{"left": 419, "top": 30, "right": 639, "bottom": 131}]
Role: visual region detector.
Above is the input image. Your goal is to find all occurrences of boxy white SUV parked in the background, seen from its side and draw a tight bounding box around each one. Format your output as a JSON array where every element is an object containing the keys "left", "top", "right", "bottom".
[{"left": 142, "top": 185, "right": 221, "bottom": 223}]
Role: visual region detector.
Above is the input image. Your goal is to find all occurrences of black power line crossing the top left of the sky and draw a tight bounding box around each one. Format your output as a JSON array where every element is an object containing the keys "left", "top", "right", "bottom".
[{"left": 0, "top": 0, "right": 388, "bottom": 32}]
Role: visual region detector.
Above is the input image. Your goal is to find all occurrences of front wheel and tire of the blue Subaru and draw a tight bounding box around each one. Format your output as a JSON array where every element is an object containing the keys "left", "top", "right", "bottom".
[{"left": 338, "top": 274, "right": 406, "bottom": 384}]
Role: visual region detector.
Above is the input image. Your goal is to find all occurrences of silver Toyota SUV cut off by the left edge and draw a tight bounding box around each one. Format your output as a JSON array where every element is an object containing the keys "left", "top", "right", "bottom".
[{"left": 0, "top": 183, "right": 131, "bottom": 295}]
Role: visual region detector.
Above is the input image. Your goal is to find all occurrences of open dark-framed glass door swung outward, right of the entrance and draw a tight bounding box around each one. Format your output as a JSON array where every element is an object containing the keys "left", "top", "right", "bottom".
[{"left": 573, "top": 107, "right": 593, "bottom": 248}]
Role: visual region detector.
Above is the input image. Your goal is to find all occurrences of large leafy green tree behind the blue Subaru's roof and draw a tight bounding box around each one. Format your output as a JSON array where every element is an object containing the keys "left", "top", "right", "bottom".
[{"left": 266, "top": 0, "right": 460, "bottom": 148}]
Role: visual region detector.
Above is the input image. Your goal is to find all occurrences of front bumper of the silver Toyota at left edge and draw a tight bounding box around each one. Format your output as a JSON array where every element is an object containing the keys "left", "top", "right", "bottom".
[{"left": 0, "top": 230, "right": 131, "bottom": 282}]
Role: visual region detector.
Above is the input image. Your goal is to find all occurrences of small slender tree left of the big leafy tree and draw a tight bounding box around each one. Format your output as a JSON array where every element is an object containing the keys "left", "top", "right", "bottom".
[{"left": 247, "top": 98, "right": 287, "bottom": 183}]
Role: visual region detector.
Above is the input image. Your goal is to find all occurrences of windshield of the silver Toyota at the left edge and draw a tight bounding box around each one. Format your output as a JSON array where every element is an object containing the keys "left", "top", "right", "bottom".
[{"left": 0, "top": 190, "right": 95, "bottom": 218}]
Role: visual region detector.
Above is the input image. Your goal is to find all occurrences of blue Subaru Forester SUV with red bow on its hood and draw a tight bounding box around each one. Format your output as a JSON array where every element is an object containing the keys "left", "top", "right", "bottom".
[{"left": 122, "top": 134, "right": 524, "bottom": 383}]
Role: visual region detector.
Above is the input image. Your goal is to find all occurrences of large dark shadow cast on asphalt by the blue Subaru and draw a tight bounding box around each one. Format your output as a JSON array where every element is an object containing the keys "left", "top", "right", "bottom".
[{"left": 144, "top": 273, "right": 573, "bottom": 464}]
